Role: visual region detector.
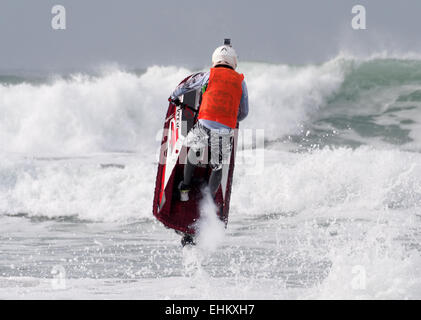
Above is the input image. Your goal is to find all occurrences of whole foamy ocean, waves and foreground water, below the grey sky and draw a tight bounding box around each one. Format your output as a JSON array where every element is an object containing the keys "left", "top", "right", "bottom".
[{"left": 0, "top": 55, "right": 421, "bottom": 299}]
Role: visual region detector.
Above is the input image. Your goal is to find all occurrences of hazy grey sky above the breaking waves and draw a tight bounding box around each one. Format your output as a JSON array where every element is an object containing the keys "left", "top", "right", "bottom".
[{"left": 0, "top": 0, "right": 421, "bottom": 70}]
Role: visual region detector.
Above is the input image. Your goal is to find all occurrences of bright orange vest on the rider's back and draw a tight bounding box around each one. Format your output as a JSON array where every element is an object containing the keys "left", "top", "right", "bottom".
[{"left": 199, "top": 67, "right": 244, "bottom": 129}]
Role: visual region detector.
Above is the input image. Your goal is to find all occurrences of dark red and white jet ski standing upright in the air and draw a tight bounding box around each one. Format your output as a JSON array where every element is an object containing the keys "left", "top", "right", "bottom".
[{"left": 153, "top": 73, "right": 238, "bottom": 236}]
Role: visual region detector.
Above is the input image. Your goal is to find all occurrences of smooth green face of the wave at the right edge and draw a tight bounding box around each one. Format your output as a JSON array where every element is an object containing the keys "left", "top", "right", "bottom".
[{"left": 292, "top": 59, "right": 421, "bottom": 149}]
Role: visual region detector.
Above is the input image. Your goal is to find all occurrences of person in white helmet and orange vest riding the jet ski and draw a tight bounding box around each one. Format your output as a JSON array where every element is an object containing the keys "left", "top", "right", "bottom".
[{"left": 170, "top": 39, "right": 249, "bottom": 201}]
